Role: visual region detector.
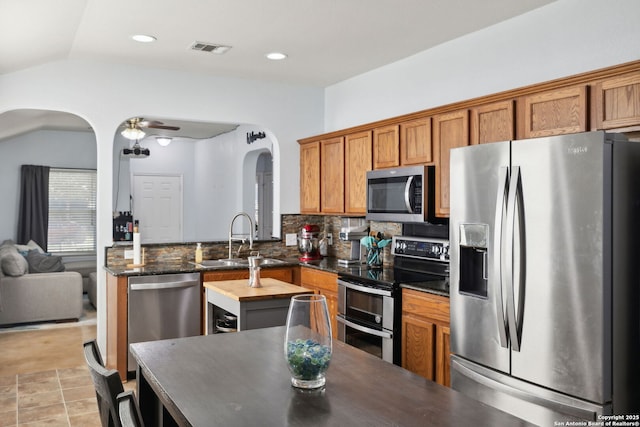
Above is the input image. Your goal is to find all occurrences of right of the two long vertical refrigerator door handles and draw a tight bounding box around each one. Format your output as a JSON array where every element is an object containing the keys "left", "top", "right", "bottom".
[{"left": 506, "top": 166, "right": 524, "bottom": 351}]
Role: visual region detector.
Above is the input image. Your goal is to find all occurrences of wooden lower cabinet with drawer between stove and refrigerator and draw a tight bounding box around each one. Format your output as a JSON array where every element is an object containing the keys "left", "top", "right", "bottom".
[{"left": 402, "top": 289, "right": 451, "bottom": 387}]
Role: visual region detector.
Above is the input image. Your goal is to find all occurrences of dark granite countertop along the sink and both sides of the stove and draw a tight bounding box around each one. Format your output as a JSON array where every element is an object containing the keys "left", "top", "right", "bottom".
[{"left": 104, "top": 257, "right": 449, "bottom": 297}]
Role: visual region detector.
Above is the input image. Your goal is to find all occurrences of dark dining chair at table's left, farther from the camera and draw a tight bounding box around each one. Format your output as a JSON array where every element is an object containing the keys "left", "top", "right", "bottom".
[{"left": 84, "top": 340, "right": 124, "bottom": 427}]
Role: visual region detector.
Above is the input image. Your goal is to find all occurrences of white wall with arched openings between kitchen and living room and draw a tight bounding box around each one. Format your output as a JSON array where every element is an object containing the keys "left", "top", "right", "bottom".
[{"left": 0, "top": 60, "right": 324, "bottom": 350}]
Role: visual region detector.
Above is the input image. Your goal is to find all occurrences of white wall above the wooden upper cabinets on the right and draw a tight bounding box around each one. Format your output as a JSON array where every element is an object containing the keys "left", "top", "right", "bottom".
[{"left": 325, "top": 0, "right": 640, "bottom": 132}]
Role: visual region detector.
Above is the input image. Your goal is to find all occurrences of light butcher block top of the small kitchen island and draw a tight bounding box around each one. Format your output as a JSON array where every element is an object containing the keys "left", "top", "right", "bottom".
[{"left": 204, "top": 278, "right": 313, "bottom": 302}]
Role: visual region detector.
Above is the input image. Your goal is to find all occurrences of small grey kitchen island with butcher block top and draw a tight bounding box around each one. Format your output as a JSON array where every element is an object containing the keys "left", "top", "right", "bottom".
[{"left": 203, "top": 278, "right": 313, "bottom": 335}]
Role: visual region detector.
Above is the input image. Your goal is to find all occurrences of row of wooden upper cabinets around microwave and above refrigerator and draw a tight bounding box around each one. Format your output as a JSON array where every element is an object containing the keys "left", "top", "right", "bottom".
[{"left": 299, "top": 61, "right": 640, "bottom": 218}]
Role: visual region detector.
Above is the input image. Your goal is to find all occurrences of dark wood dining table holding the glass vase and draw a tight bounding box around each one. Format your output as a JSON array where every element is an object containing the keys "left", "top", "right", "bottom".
[{"left": 131, "top": 327, "right": 531, "bottom": 427}]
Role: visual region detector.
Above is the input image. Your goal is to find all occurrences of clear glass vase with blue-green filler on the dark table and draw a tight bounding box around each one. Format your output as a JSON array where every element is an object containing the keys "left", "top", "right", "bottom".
[{"left": 284, "top": 294, "right": 332, "bottom": 389}]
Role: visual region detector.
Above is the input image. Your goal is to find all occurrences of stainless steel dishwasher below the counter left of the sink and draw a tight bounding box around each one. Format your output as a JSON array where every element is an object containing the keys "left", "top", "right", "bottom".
[{"left": 127, "top": 273, "right": 202, "bottom": 371}]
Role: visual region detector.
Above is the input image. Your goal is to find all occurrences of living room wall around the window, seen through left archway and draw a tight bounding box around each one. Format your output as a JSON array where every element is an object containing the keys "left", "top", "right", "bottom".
[{"left": 0, "top": 130, "right": 96, "bottom": 243}]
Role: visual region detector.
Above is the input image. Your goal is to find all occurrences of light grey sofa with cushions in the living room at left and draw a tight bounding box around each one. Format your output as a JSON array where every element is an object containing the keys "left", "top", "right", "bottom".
[{"left": 0, "top": 240, "right": 83, "bottom": 326}]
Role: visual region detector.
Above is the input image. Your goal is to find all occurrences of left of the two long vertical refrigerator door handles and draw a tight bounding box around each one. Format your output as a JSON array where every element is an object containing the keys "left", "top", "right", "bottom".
[{"left": 493, "top": 166, "right": 509, "bottom": 348}]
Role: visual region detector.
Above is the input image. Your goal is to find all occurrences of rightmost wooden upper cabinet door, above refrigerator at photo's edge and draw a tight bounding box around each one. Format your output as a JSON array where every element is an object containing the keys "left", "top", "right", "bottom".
[{"left": 595, "top": 72, "right": 640, "bottom": 129}]
